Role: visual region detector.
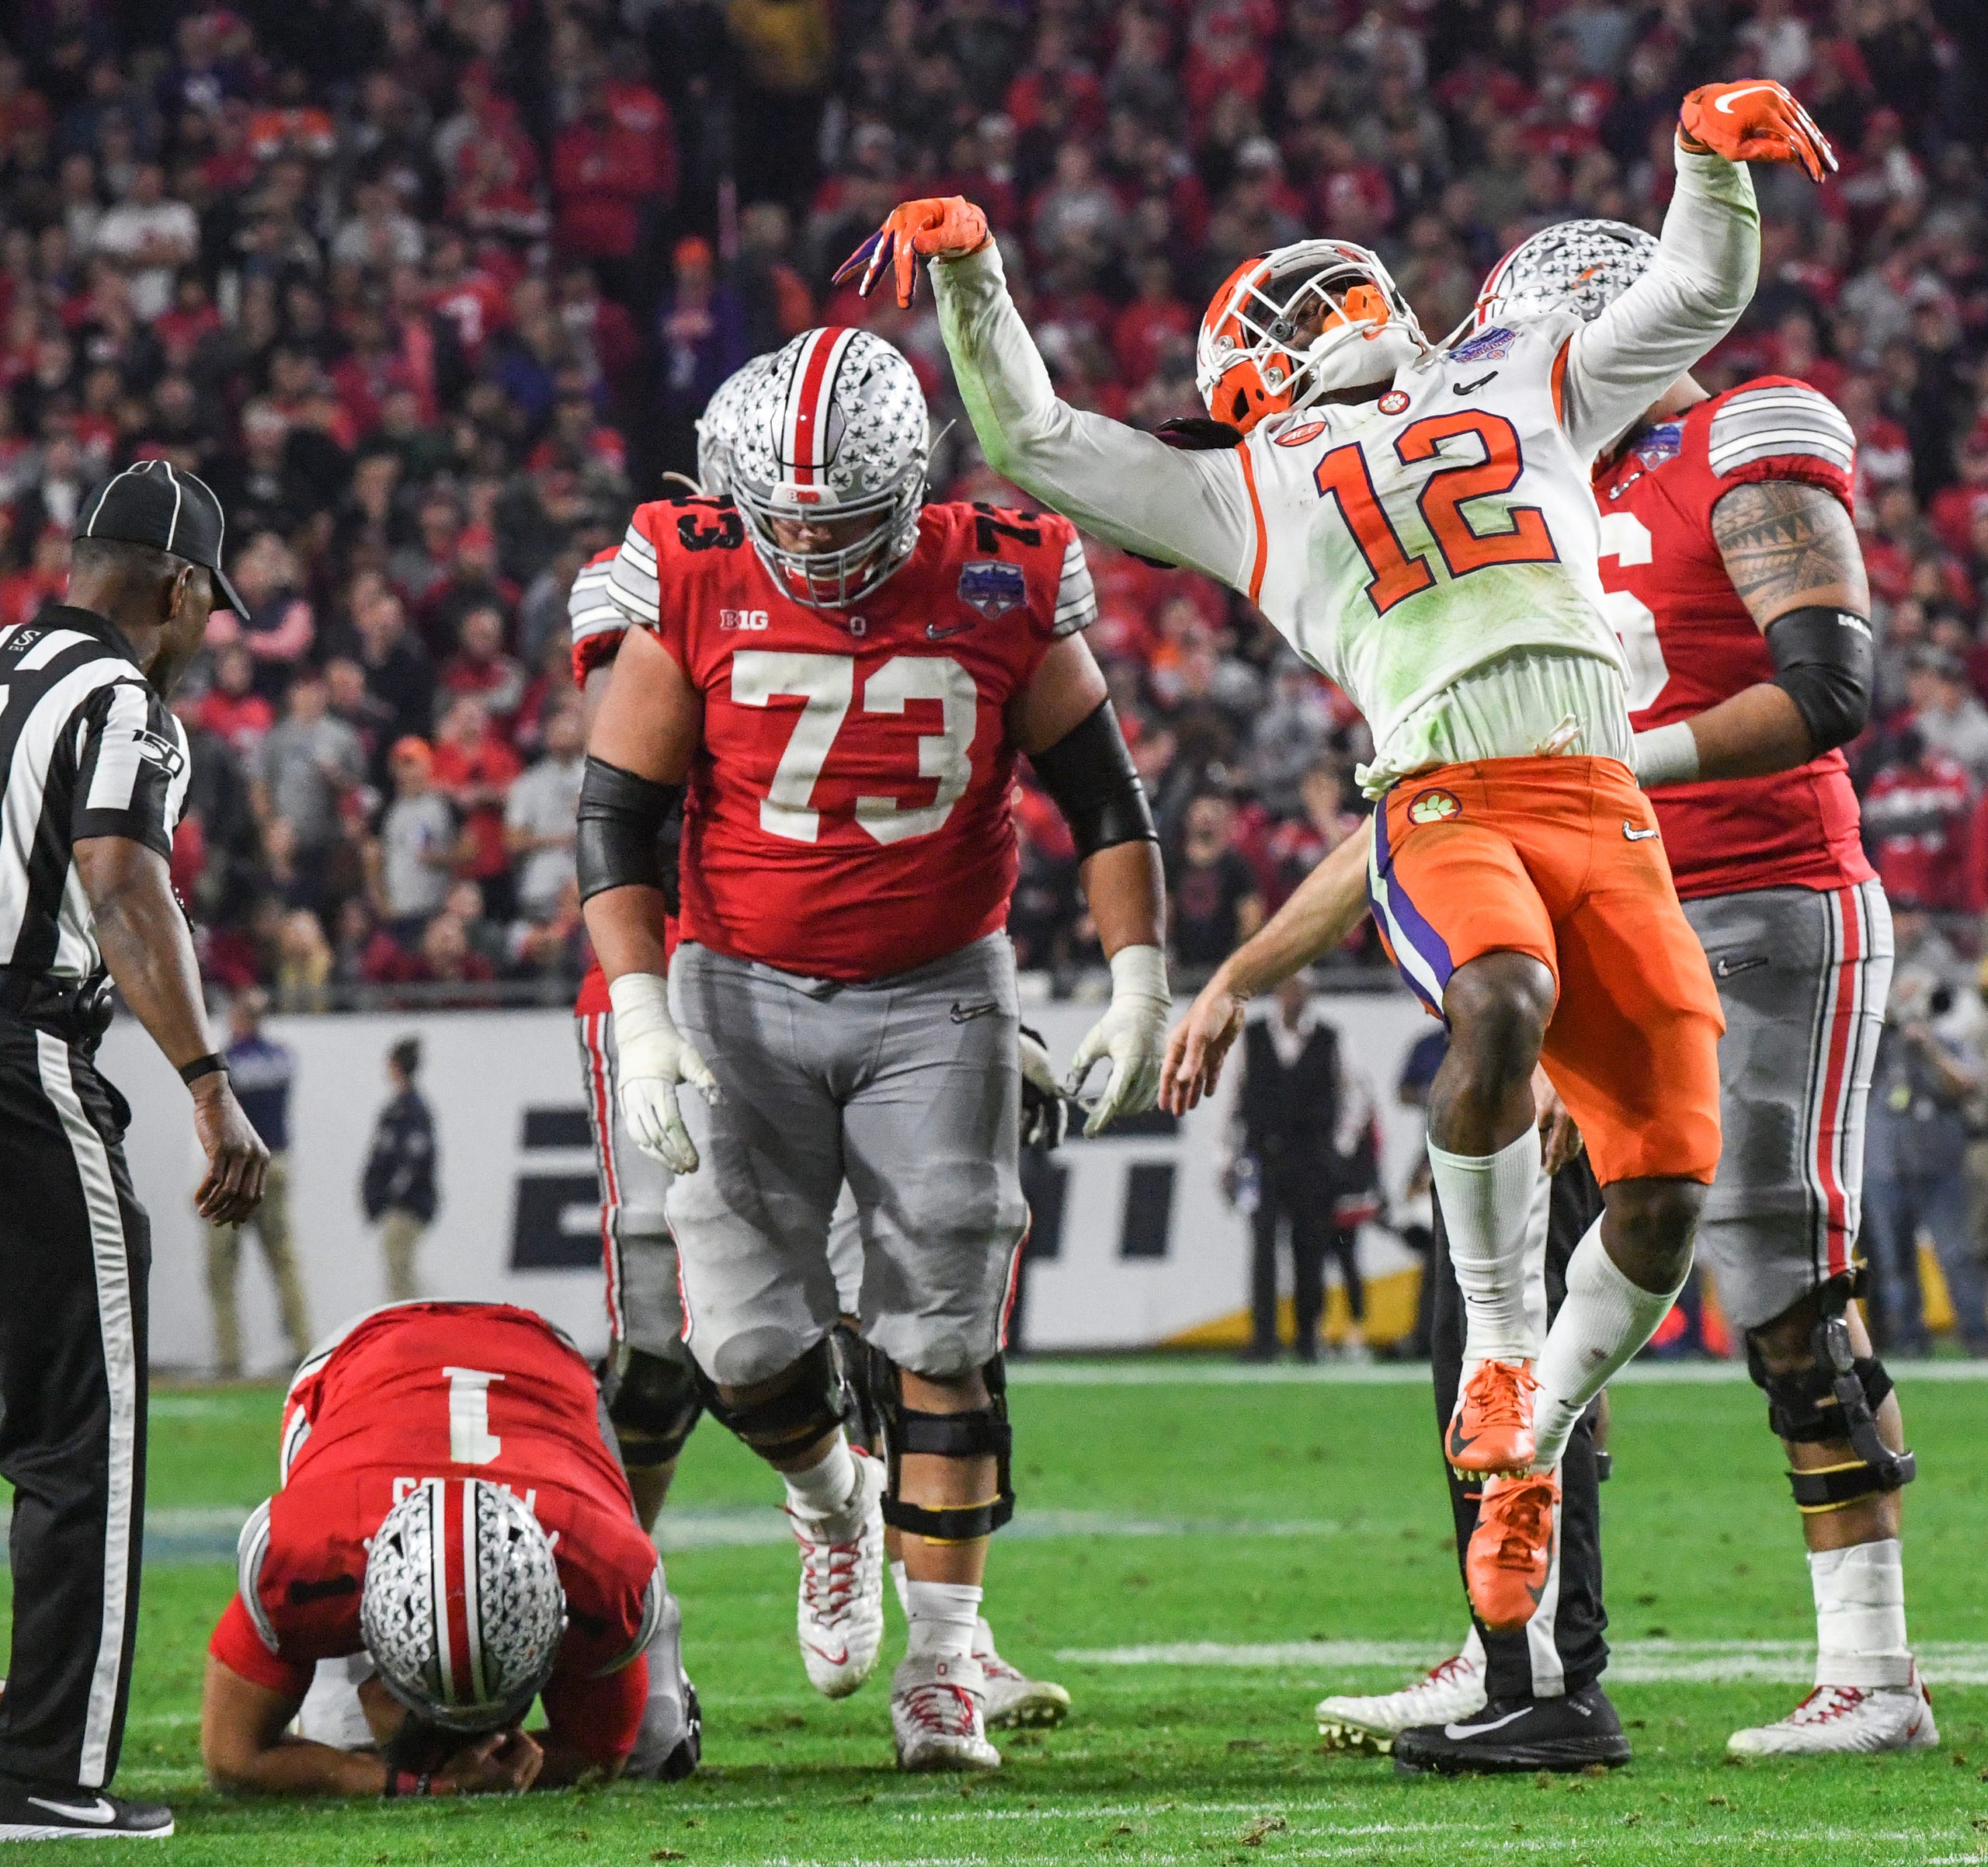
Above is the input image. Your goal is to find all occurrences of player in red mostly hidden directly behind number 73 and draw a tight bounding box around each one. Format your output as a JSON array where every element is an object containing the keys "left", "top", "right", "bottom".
[{"left": 568, "top": 352, "right": 1069, "bottom": 1730}]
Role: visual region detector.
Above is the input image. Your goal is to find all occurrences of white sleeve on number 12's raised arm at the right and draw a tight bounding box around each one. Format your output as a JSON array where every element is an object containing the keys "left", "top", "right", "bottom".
[{"left": 1561, "top": 149, "right": 1760, "bottom": 459}]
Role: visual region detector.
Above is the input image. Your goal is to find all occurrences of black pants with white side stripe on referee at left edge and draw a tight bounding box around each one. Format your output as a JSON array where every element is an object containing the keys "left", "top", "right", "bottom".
[{"left": 0, "top": 1014, "right": 151, "bottom": 1789}]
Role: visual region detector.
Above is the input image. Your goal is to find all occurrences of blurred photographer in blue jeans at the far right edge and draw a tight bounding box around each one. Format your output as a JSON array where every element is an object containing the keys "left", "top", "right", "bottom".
[{"left": 1865, "top": 968, "right": 1988, "bottom": 1356}]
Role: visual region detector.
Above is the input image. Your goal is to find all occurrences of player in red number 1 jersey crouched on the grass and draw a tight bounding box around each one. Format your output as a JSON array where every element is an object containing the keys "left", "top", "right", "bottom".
[{"left": 201, "top": 1302, "right": 700, "bottom": 1796}]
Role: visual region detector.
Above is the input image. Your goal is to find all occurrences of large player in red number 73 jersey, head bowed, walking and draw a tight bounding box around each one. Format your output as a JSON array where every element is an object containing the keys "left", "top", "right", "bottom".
[{"left": 581, "top": 330, "right": 1169, "bottom": 1770}]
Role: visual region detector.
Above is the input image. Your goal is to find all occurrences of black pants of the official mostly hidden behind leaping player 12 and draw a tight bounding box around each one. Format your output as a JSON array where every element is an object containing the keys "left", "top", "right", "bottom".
[{"left": 1430, "top": 1155, "right": 1608, "bottom": 1698}]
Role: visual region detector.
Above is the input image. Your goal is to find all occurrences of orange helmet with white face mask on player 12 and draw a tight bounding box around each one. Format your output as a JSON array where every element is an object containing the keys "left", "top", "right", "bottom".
[{"left": 1195, "top": 241, "right": 1430, "bottom": 433}]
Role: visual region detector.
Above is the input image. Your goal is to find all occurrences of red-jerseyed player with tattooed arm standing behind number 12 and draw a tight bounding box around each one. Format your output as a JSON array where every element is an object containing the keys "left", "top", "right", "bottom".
[{"left": 1582, "top": 237, "right": 1938, "bottom": 1756}]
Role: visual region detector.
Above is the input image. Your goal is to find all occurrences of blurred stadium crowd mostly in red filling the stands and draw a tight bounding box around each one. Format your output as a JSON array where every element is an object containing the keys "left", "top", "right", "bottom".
[{"left": 0, "top": 0, "right": 1988, "bottom": 1008}]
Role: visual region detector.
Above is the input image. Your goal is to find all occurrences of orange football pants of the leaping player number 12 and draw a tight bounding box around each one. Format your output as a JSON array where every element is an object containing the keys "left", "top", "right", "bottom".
[{"left": 1368, "top": 757, "right": 1726, "bottom": 1185}]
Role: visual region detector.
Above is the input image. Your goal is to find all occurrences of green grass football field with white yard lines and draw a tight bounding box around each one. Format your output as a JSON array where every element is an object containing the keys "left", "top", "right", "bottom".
[{"left": 19, "top": 1362, "right": 1988, "bottom": 1867}]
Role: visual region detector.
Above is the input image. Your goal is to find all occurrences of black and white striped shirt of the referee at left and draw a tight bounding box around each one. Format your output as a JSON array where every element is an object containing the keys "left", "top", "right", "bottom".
[{"left": 0, "top": 604, "right": 191, "bottom": 979}]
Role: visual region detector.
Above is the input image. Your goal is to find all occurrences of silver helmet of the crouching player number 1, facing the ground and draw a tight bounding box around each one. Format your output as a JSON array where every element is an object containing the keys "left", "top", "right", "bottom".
[{"left": 360, "top": 1477, "right": 567, "bottom": 1732}]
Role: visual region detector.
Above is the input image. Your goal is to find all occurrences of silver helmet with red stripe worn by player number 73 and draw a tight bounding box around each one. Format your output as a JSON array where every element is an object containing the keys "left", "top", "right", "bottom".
[{"left": 732, "top": 326, "right": 930, "bottom": 608}]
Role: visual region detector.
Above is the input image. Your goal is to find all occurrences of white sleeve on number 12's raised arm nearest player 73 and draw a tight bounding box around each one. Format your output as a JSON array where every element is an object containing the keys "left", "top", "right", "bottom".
[{"left": 933, "top": 241, "right": 1256, "bottom": 590}]
